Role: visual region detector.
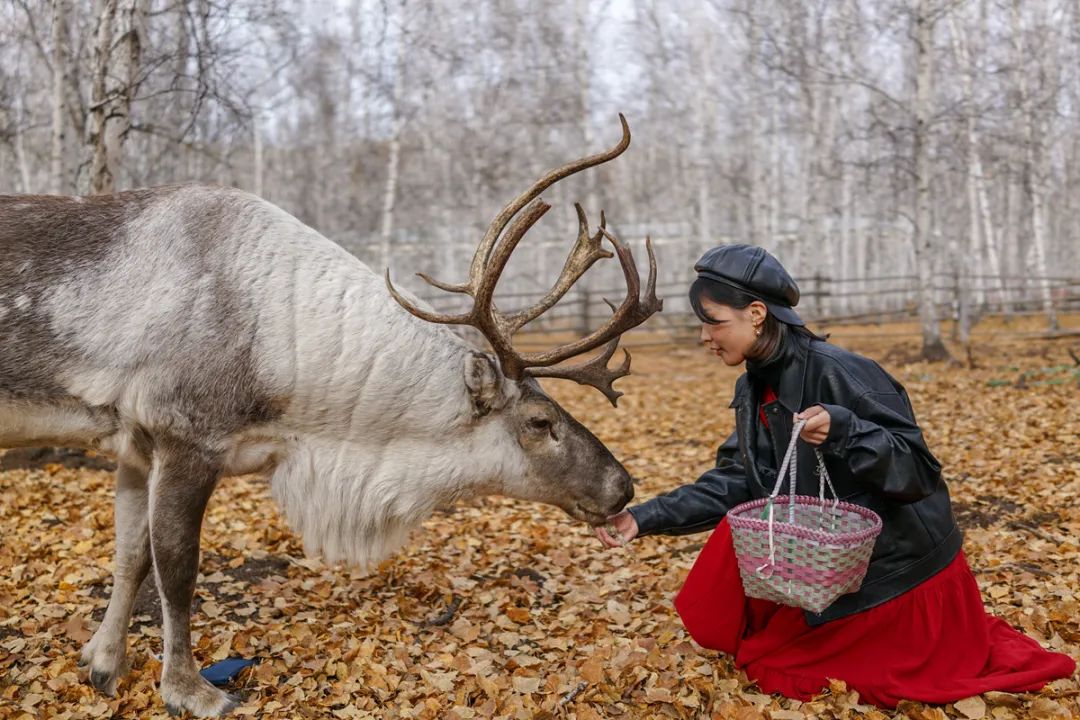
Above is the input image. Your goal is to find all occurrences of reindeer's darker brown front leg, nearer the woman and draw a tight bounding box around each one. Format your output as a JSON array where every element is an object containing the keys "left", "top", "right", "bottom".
[{"left": 150, "top": 445, "right": 237, "bottom": 717}]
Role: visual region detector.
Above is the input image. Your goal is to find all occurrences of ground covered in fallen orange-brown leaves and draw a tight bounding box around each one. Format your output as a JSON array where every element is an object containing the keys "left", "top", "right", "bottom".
[{"left": 0, "top": 318, "right": 1080, "bottom": 720}]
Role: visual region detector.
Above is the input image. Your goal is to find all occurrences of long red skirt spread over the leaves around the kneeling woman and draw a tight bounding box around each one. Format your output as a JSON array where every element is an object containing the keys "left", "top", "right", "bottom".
[{"left": 675, "top": 519, "right": 1076, "bottom": 708}]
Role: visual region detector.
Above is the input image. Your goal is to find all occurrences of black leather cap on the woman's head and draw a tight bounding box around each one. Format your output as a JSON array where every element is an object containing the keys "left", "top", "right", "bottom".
[{"left": 693, "top": 244, "right": 806, "bottom": 325}]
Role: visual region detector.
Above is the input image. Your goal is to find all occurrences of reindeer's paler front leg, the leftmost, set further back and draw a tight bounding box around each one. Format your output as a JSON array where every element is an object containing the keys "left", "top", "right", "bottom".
[{"left": 79, "top": 463, "right": 150, "bottom": 695}]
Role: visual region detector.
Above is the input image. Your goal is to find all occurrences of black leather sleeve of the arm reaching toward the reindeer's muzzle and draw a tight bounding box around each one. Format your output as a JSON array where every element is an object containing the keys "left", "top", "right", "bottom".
[{"left": 630, "top": 433, "right": 751, "bottom": 536}]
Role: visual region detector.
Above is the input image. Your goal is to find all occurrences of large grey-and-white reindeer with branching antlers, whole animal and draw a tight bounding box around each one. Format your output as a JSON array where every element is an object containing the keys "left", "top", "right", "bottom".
[{"left": 0, "top": 116, "right": 662, "bottom": 717}]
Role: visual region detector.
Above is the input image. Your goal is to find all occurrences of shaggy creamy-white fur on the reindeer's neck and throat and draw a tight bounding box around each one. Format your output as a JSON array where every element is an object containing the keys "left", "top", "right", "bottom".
[{"left": 244, "top": 194, "right": 524, "bottom": 568}]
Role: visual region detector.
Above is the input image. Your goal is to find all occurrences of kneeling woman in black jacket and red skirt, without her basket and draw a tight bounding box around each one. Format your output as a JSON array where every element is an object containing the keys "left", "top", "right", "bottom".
[{"left": 596, "top": 245, "right": 1076, "bottom": 708}]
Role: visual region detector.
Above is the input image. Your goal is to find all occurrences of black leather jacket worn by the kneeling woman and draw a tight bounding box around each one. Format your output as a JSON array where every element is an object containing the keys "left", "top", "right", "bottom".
[{"left": 630, "top": 334, "right": 962, "bottom": 625}]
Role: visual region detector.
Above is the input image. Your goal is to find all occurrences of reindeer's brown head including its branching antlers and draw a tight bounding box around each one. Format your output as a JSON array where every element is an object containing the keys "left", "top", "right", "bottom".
[{"left": 387, "top": 114, "right": 663, "bottom": 525}]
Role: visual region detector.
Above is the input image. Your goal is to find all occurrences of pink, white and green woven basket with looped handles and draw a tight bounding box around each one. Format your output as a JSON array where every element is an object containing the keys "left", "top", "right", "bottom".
[{"left": 728, "top": 420, "right": 881, "bottom": 612}]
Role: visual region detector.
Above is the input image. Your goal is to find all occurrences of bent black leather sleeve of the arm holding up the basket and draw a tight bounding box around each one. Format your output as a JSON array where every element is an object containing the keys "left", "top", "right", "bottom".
[{"left": 821, "top": 389, "right": 941, "bottom": 503}]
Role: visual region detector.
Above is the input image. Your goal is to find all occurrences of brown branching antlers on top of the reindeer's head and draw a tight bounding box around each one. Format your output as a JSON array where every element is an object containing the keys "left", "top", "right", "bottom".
[{"left": 387, "top": 113, "right": 663, "bottom": 405}]
